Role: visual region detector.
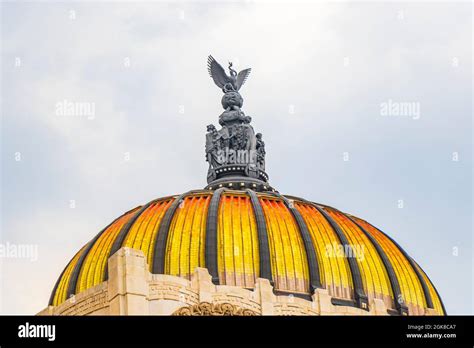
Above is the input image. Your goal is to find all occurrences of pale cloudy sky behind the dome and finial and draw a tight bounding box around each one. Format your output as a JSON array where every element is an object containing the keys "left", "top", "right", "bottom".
[{"left": 0, "top": 1, "right": 474, "bottom": 314}]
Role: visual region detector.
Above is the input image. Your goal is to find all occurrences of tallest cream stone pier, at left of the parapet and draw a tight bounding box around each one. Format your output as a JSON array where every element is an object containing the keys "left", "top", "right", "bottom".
[{"left": 108, "top": 248, "right": 149, "bottom": 315}]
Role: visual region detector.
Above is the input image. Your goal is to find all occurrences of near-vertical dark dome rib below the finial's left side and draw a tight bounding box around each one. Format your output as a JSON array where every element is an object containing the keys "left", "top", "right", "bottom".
[{"left": 206, "top": 187, "right": 226, "bottom": 284}]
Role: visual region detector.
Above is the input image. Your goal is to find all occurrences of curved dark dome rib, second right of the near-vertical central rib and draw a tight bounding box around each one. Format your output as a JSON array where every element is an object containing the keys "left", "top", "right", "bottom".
[{"left": 276, "top": 194, "right": 323, "bottom": 294}]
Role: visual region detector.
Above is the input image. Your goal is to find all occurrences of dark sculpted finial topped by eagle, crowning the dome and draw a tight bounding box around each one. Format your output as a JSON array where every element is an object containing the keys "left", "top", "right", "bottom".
[{"left": 206, "top": 56, "right": 271, "bottom": 190}]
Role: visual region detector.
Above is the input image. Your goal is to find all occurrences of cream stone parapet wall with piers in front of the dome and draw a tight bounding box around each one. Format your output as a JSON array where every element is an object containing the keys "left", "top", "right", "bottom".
[{"left": 38, "top": 248, "right": 434, "bottom": 315}]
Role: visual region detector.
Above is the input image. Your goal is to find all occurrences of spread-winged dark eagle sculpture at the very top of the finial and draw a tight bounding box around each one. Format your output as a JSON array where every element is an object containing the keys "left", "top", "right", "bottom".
[{"left": 207, "top": 56, "right": 252, "bottom": 93}]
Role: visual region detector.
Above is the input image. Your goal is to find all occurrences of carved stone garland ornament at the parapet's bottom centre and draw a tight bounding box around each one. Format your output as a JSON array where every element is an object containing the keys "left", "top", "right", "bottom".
[{"left": 172, "top": 302, "right": 259, "bottom": 316}]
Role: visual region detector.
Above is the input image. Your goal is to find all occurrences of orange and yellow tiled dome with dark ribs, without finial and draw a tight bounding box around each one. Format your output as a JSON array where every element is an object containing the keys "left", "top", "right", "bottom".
[{"left": 50, "top": 189, "right": 445, "bottom": 315}]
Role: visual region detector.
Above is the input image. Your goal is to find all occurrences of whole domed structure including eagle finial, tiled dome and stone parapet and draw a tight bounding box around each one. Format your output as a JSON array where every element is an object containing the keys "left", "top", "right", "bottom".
[{"left": 47, "top": 56, "right": 446, "bottom": 315}]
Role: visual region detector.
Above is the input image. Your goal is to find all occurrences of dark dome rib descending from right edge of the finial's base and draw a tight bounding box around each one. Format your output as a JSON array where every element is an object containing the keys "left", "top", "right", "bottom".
[{"left": 246, "top": 189, "right": 273, "bottom": 285}]
